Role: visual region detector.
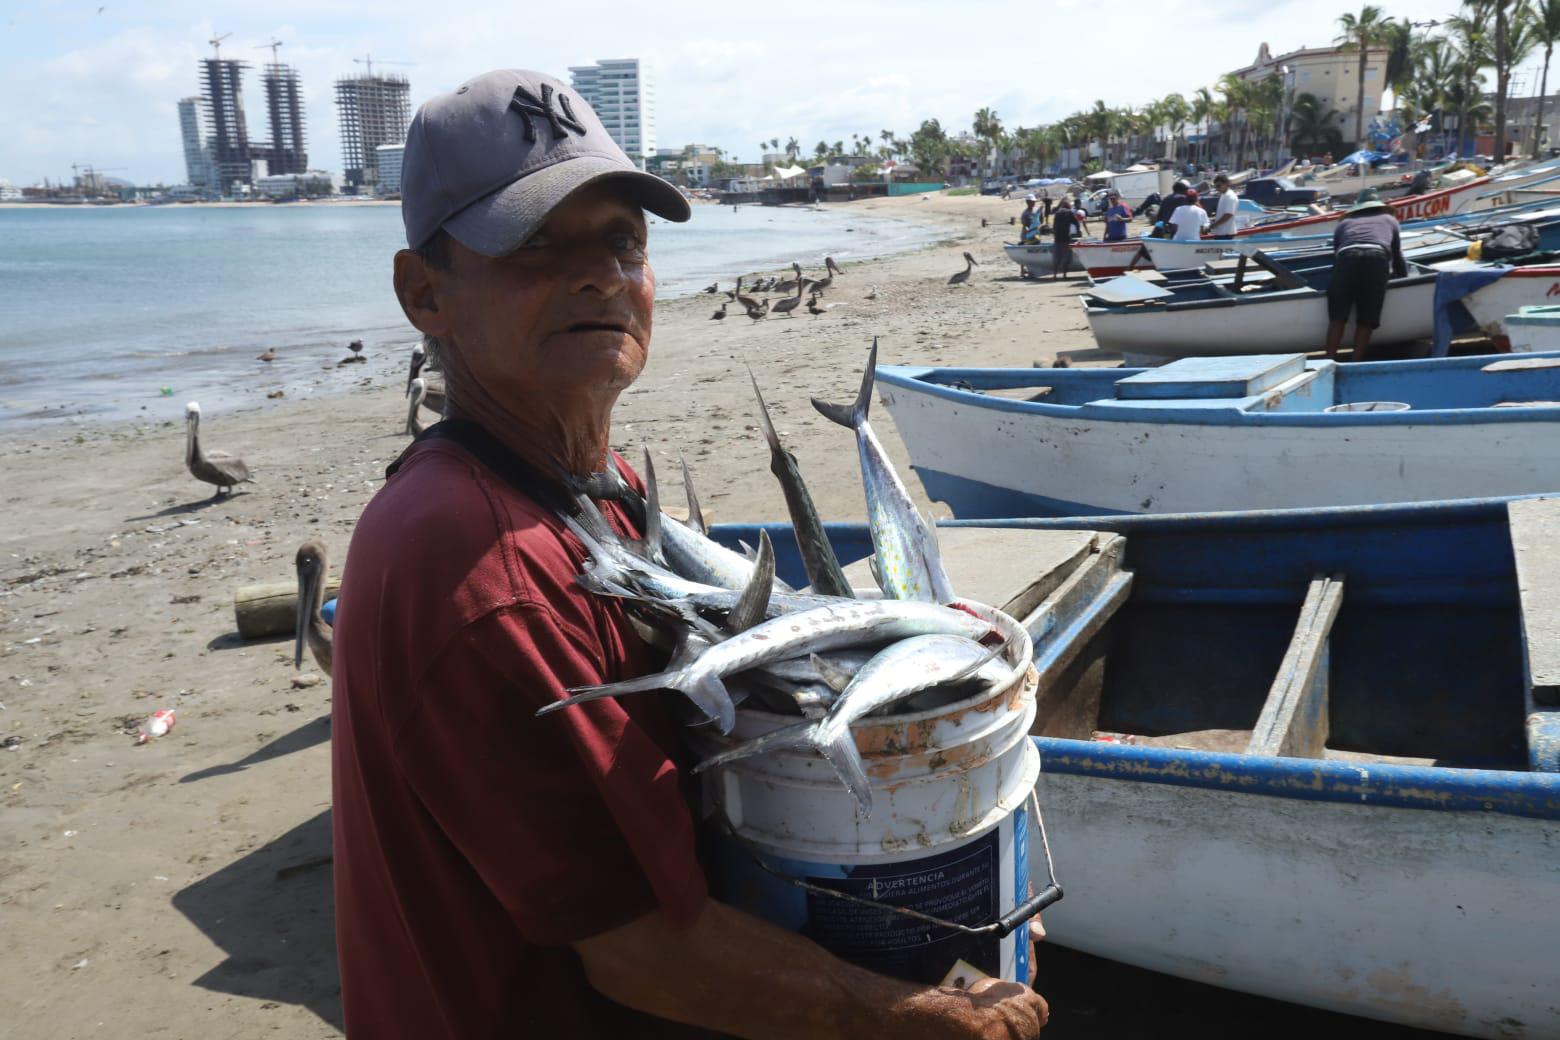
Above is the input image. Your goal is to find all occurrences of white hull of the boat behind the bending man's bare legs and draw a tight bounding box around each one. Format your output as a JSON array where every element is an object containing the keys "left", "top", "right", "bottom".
[{"left": 1084, "top": 279, "right": 1435, "bottom": 361}]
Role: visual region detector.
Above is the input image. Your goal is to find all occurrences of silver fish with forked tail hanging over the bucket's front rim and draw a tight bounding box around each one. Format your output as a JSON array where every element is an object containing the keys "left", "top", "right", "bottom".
[{"left": 694, "top": 635, "right": 1003, "bottom": 817}]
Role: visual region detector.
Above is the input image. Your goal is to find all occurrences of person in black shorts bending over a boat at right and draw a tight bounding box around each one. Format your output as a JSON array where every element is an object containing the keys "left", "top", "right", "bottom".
[{"left": 1328, "top": 189, "right": 1409, "bottom": 362}]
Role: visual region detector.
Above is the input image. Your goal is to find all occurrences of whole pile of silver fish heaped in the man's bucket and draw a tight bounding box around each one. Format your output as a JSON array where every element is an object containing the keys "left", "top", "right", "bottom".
[{"left": 538, "top": 340, "right": 1011, "bottom": 814}]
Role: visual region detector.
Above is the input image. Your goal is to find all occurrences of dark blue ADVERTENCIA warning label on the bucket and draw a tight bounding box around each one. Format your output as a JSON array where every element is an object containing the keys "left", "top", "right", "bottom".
[{"left": 802, "top": 831, "right": 1000, "bottom": 985}]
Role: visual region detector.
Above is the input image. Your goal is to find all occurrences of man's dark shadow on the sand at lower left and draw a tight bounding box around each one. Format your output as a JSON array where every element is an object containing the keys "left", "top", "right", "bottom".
[{"left": 173, "top": 810, "right": 345, "bottom": 1029}]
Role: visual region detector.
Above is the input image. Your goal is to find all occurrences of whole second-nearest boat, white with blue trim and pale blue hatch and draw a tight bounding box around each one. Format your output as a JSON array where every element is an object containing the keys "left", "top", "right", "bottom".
[{"left": 877, "top": 354, "right": 1560, "bottom": 518}]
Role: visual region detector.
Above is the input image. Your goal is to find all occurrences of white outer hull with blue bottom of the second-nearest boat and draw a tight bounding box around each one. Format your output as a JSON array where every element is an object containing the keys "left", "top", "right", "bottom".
[{"left": 878, "top": 382, "right": 1560, "bottom": 518}]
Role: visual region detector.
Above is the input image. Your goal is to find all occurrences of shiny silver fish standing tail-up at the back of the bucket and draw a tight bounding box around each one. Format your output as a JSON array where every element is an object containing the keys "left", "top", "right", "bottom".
[{"left": 813, "top": 338, "right": 955, "bottom": 603}]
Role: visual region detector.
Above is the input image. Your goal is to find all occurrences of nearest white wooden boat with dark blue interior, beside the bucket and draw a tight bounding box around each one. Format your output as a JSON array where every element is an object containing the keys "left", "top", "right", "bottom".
[{"left": 716, "top": 499, "right": 1560, "bottom": 1037}]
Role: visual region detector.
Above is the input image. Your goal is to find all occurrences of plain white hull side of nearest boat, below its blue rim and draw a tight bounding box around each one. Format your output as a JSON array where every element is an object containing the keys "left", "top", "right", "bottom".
[{"left": 1030, "top": 764, "right": 1560, "bottom": 1037}]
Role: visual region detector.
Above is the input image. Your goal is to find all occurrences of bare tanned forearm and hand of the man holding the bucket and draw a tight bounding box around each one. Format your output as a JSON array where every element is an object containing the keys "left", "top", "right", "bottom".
[{"left": 574, "top": 900, "right": 1048, "bottom": 1040}]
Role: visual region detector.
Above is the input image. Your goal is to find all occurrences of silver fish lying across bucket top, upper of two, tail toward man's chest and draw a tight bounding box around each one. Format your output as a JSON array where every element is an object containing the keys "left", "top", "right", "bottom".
[{"left": 537, "top": 600, "right": 992, "bottom": 733}]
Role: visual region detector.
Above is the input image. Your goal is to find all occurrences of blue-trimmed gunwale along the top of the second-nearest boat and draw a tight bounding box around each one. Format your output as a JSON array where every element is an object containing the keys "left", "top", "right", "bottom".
[{"left": 877, "top": 351, "right": 1560, "bottom": 424}]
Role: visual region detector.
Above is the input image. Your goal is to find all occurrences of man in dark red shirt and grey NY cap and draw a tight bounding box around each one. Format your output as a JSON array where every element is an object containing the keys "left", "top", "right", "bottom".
[{"left": 332, "top": 70, "right": 1047, "bottom": 1040}]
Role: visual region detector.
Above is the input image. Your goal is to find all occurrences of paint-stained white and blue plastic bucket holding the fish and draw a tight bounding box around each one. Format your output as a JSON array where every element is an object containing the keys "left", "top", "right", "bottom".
[{"left": 694, "top": 603, "right": 1041, "bottom": 984}]
